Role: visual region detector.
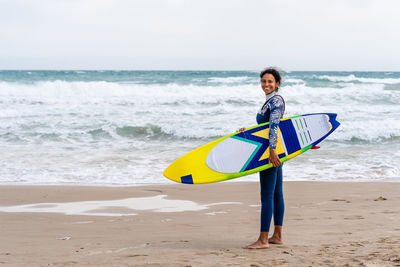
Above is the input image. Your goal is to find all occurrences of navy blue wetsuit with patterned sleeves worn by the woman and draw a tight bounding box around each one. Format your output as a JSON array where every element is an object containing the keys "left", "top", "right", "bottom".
[{"left": 257, "top": 95, "right": 285, "bottom": 232}]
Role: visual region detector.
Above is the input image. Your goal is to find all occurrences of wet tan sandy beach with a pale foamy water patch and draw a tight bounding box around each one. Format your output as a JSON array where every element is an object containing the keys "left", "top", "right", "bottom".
[{"left": 0, "top": 181, "right": 400, "bottom": 266}]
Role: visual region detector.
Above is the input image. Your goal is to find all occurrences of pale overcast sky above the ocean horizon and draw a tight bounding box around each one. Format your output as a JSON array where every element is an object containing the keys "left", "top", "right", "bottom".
[{"left": 0, "top": 0, "right": 400, "bottom": 71}]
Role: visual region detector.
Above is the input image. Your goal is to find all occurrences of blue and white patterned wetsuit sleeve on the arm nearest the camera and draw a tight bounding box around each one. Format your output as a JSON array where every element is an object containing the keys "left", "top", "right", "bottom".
[{"left": 269, "top": 97, "right": 285, "bottom": 149}]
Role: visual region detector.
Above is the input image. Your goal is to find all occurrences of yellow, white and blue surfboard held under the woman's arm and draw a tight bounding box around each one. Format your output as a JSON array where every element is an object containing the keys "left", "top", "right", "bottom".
[{"left": 164, "top": 113, "right": 340, "bottom": 184}]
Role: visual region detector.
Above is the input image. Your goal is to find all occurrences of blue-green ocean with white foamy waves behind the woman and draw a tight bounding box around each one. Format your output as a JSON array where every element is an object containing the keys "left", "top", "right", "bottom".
[{"left": 0, "top": 70, "right": 400, "bottom": 186}]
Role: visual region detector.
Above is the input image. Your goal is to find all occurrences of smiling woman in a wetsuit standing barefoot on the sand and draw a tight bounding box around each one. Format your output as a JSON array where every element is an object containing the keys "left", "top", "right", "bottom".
[{"left": 239, "top": 68, "right": 285, "bottom": 249}]
